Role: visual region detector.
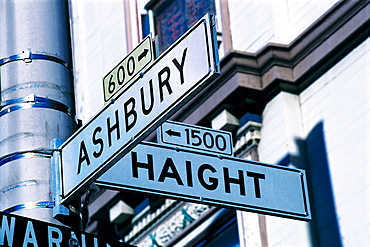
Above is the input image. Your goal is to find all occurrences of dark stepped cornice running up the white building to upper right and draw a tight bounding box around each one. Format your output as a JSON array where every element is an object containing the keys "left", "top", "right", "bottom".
[{"left": 172, "top": 1, "right": 370, "bottom": 126}]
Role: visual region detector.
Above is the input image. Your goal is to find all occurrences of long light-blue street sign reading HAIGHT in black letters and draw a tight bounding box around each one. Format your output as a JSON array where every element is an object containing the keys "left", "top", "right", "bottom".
[{"left": 96, "top": 142, "right": 311, "bottom": 221}]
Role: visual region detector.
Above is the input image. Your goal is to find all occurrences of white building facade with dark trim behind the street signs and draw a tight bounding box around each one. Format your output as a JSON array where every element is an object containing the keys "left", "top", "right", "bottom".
[{"left": 1, "top": 0, "right": 370, "bottom": 247}]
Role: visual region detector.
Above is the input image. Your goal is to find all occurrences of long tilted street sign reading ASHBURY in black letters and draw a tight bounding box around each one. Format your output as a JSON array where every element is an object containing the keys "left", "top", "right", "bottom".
[{"left": 60, "top": 15, "right": 219, "bottom": 203}]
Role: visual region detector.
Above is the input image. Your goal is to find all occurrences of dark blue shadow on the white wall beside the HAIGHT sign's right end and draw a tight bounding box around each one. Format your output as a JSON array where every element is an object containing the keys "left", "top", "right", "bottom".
[{"left": 278, "top": 122, "right": 343, "bottom": 246}]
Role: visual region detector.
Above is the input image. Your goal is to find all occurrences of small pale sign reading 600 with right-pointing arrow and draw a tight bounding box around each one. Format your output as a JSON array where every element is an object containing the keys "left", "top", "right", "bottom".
[{"left": 103, "top": 34, "right": 154, "bottom": 102}]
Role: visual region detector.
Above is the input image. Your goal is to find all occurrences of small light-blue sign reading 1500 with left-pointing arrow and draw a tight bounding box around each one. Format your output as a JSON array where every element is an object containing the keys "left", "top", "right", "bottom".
[{"left": 157, "top": 121, "right": 233, "bottom": 155}]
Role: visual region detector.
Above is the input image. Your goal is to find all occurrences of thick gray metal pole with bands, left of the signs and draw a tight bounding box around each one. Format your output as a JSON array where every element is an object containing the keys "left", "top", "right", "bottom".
[{"left": 0, "top": 0, "right": 76, "bottom": 226}]
